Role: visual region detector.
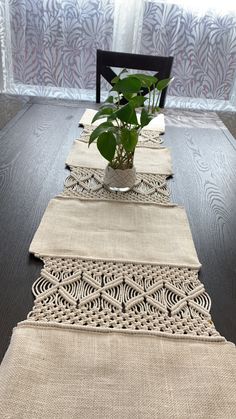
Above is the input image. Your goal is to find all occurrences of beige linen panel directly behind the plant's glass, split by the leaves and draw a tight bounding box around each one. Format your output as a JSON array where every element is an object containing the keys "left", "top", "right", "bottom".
[{"left": 66, "top": 140, "right": 172, "bottom": 175}]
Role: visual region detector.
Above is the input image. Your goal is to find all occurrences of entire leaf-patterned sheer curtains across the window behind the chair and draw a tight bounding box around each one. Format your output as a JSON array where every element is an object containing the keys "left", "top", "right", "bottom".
[{"left": 0, "top": 0, "right": 236, "bottom": 109}]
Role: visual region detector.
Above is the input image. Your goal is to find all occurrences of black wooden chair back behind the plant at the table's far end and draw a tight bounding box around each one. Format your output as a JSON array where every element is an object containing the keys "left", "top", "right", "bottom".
[{"left": 96, "top": 49, "right": 173, "bottom": 108}]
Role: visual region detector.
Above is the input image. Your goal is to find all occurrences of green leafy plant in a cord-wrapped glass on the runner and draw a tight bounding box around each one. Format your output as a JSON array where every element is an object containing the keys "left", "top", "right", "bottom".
[{"left": 89, "top": 69, "right": 171, "bottom": 191}]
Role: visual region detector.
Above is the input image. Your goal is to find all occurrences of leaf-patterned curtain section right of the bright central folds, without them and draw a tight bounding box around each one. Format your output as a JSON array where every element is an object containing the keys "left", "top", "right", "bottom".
[{"left": 140, "top": 1, "right": 236, "bottom": 100}]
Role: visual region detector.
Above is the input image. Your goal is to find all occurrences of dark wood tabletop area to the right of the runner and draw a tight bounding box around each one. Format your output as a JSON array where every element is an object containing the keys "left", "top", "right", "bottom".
[{"left": 165, "top": 110, "right": 236, "bottom": 342}]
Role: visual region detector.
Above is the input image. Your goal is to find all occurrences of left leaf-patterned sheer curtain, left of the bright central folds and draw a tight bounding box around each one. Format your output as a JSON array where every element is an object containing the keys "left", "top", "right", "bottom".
[{"left": 0, "top": 0, "right": 114, "bottom": 99}]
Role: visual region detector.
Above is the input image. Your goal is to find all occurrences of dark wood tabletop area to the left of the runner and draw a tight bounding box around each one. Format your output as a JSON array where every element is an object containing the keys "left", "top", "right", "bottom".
[{"left": 0, "top": 104, "right": 83, "bottom": 358}]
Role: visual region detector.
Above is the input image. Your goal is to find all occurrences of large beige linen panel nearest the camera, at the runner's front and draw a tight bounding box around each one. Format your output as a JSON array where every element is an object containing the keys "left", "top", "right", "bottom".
[{"left": 0, "top": 325, "right": 236, "bottom": 419}]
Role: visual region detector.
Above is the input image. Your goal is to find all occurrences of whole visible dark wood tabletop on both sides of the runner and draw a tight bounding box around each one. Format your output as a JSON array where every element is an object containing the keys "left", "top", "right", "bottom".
[{"left": 0, "top": 103, "right": 236, "bottom": 359}]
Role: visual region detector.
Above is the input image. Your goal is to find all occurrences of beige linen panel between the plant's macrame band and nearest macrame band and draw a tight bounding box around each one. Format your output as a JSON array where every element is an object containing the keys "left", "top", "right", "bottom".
[{"left": 30, "top": 196, "right": 200, "bottom": 267}]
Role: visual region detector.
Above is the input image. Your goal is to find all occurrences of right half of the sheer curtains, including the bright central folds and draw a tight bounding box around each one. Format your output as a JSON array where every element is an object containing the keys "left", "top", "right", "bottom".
[{"left": 113, "top": 0, "right": 236, "bottom": 110}]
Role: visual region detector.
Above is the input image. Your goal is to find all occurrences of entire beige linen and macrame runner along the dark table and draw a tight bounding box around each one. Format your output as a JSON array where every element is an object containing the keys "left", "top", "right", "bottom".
[{"left": 0, "top": 111, "right": 236, "bottom": 419}]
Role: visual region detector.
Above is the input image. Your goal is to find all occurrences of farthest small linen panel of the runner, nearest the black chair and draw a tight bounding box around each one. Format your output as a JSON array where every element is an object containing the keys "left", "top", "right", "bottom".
[{"left": 80, "top": 109, "right": 165, "bottom": 133}]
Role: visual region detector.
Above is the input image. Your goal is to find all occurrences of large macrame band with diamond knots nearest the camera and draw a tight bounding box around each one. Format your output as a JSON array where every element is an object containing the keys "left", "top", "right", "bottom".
[{"left": 28, "top": 257, "right": 219, "bottom": 337}]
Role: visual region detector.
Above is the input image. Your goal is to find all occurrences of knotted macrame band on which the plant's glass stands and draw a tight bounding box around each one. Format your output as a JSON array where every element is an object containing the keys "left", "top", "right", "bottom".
[{"left": 63, "top": 167, "right": 170, "bottom": 204}]
